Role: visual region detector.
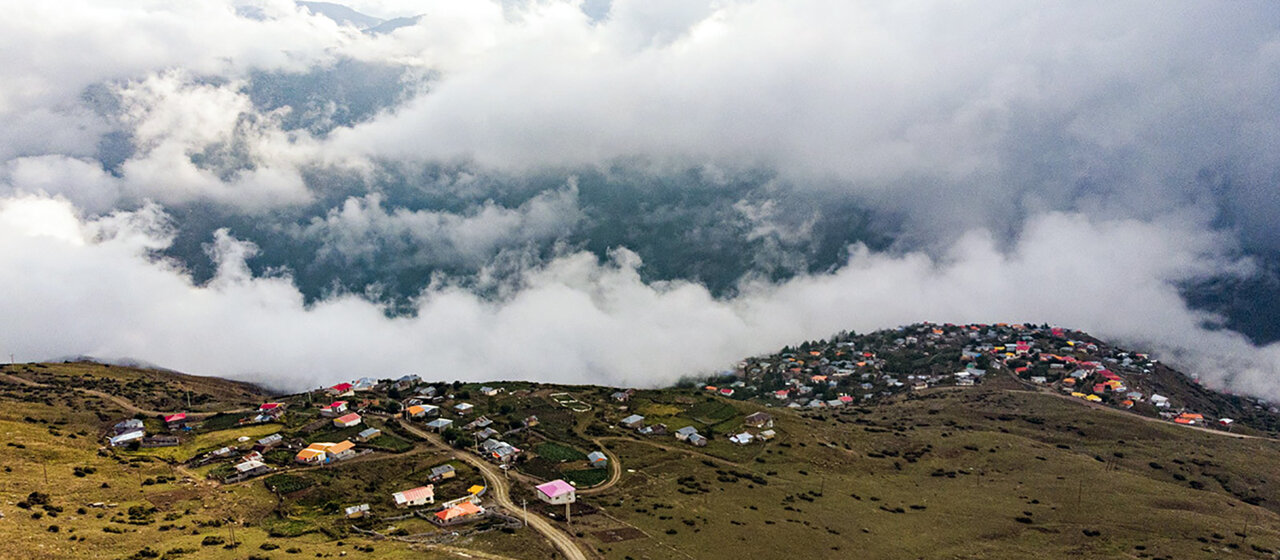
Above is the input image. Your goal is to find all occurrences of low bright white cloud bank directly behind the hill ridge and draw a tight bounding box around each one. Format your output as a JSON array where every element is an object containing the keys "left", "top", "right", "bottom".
[{"left": 0, "top": 197, "right": 1280, "bottom": 398}]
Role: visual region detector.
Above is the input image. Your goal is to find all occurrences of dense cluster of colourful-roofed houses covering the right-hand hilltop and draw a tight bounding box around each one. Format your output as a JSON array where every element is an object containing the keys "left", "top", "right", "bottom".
[{"left": 705, "top": 323, "right": 1280, "bottom": 430}]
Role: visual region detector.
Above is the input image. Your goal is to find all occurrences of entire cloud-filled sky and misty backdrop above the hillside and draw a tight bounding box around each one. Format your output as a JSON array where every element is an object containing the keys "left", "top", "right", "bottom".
[{"left": 0, "top": 0, "right": 1280, "bottom": 399}]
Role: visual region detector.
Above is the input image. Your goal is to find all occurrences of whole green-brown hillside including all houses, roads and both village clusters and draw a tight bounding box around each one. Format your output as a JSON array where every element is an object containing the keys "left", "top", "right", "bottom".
[{"left": 0, "top": 323, "right": 1280, "bottom": 560}]
